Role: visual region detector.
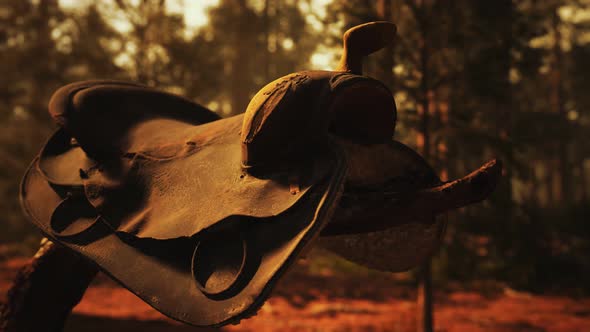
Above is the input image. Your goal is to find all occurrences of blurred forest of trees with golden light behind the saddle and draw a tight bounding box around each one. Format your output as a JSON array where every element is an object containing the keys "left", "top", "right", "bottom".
[{"left": 0, "top": 0, "right": 590, "bottom": 293}]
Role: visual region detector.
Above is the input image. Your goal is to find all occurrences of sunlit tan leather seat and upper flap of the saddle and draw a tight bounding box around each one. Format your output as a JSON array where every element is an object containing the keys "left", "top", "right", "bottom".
[{"left": 39, "top": 116, "right": 332, "bottom": 240}]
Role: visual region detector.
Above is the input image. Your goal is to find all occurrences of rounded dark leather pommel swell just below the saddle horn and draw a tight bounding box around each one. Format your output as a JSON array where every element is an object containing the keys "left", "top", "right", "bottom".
[{"left": 241, "top": 71, "right": 396, "bottom": 167}]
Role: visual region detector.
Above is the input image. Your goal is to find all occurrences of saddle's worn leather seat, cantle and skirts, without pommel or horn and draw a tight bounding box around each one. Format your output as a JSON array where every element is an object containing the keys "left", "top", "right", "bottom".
[{"left": 21, "top": 81, "right": 346, "bottom": 326}]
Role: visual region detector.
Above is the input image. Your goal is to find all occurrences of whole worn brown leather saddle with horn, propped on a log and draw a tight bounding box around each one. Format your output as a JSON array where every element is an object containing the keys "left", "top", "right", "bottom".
[{"left": 21, "top": 22, "right": 444, "bottom": 326}]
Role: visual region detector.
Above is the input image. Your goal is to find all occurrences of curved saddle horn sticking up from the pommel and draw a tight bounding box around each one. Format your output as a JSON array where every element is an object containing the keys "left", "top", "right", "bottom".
[{"left": 336, "top": 21, "right": 397, "bottom": 75}]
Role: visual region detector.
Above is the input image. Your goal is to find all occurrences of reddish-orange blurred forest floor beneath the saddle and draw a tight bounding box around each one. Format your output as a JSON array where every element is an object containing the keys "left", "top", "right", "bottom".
[{"left": 0, "top": 250, "right": 590, "bottom": 332}]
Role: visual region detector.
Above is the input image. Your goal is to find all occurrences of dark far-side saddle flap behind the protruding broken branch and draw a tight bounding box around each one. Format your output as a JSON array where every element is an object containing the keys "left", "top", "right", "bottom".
[{"left": 318, "top": 140, "right": 447, "bottom": 272}]
